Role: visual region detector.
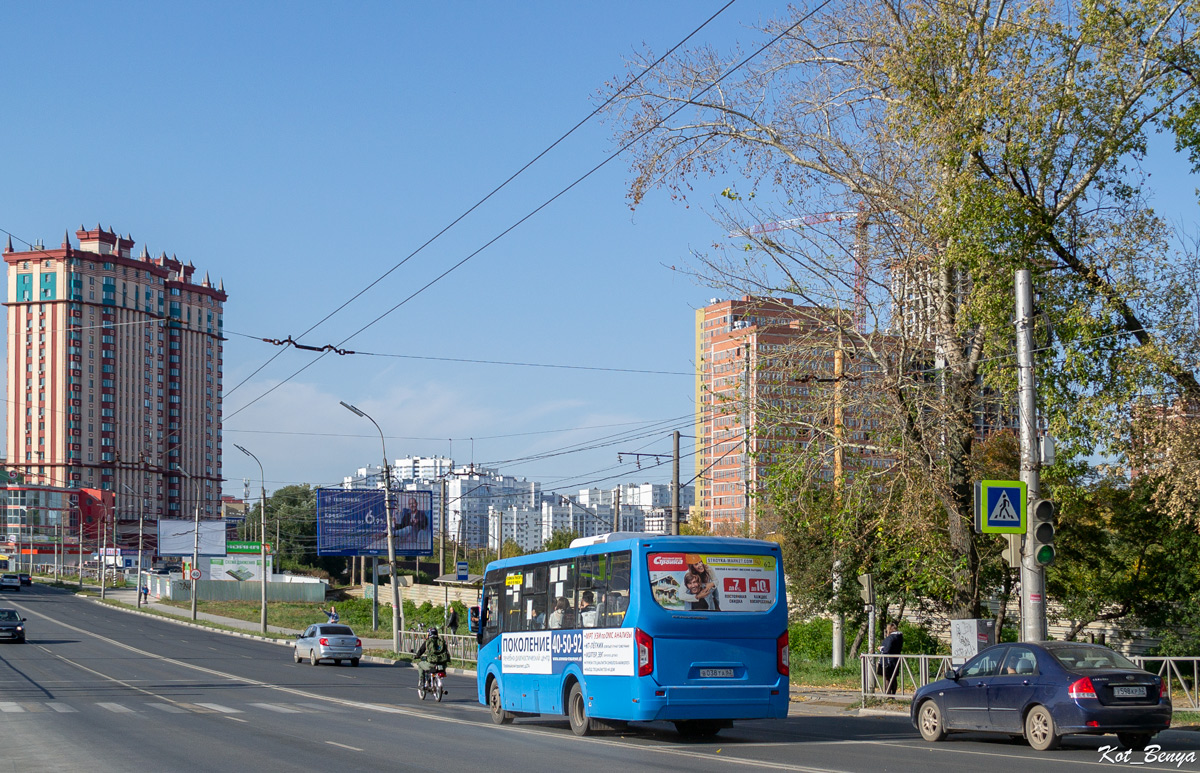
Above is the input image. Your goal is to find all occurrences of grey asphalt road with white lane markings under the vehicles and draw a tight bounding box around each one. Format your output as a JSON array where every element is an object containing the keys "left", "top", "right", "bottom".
[{"left": 0, "top": 586, "right": 1200, "bottom": 773}]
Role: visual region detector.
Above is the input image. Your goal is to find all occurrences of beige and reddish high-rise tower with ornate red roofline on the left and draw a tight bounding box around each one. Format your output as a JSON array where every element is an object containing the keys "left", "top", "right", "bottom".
[{"left": 4, "top": 226, "right": 226, "bottom": 547}]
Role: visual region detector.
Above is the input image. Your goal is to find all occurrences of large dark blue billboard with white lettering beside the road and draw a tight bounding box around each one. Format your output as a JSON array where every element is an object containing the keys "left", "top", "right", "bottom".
[{"left": 317, "top": 489, "right": 433, "bottom": 557}]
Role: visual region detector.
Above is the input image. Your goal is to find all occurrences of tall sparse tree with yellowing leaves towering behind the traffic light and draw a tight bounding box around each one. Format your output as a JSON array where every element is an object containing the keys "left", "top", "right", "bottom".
[{"left": 614, "top": 0, "right": 1200, "bottom": 617}]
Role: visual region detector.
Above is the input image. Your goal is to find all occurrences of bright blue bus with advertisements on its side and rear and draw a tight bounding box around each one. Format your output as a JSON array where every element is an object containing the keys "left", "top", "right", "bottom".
[{"left": 473, "top": 533, "right": 788, "bottom": 737}]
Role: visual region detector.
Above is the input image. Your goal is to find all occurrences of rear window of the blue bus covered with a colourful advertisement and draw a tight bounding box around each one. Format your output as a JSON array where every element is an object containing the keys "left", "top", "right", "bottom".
[{"left": 646, "top": 553, "right": 779, "bottom": 612}]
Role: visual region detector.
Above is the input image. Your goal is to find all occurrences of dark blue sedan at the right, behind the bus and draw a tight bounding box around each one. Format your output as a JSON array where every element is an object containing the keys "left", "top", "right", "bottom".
[{"left": 911, "top": 641, "right": 1171, "bottom": 751}]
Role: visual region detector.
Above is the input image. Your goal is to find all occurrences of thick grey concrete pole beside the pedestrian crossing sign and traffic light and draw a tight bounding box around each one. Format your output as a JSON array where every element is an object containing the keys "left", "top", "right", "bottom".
[{"left": 1017, "top": 269, "right": 1046, "bottom": 641}]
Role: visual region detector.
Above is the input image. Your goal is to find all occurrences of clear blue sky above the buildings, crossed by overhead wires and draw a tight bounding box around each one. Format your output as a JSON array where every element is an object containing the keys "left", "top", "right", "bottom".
[{"left": 0, "top": 0, "right": 1195, "bottom": 495}]
